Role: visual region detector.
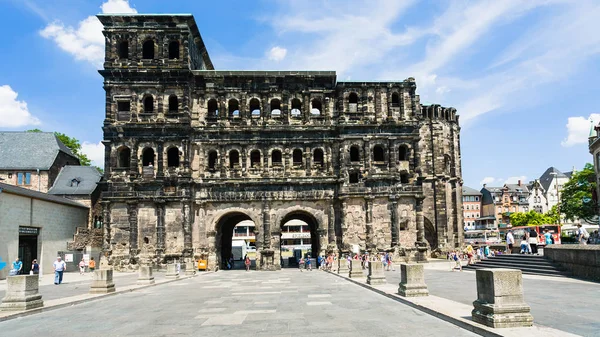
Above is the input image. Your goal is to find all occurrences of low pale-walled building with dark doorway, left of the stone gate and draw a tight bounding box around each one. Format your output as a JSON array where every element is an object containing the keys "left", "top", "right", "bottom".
[{"left": 0, "top": 183, "right": 89, "bottom": 279}]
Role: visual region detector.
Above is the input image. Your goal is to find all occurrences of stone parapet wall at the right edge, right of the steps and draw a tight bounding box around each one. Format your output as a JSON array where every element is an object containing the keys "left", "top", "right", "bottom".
[{"left": 544, "top": 245, "right": 600, "bottom": 282}]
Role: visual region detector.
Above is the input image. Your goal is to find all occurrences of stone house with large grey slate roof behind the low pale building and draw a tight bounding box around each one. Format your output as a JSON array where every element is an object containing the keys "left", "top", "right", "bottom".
[{"left": 0, "top": 131, "right": 79, "bottom": 192}]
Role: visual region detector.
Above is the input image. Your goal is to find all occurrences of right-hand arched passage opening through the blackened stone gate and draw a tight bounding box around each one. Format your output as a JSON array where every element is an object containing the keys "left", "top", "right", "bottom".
[{"left": 279, "top": 211, "right": 321, "bottom": 268}]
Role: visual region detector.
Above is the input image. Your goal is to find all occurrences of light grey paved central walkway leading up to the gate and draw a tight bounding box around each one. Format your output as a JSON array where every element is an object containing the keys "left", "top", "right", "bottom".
[{"left": 0, "top": 270, "right": 473, "bottom": 337}]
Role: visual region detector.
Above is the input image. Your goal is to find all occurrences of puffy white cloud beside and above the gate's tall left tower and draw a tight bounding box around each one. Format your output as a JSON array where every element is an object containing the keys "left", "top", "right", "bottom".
[{"left": 40, "top": 0, "right": 137, "bottom": 67}]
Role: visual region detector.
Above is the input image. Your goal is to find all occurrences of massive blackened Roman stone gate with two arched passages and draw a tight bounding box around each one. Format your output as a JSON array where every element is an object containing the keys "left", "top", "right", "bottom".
[{"left": 98, "top": 14, "right": 463, "bottom": 270}]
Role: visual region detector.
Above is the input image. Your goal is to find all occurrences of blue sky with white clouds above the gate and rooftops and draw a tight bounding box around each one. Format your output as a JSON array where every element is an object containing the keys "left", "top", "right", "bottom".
[{"left": 0, "top": 0, "right": 600, "bottom": 188}]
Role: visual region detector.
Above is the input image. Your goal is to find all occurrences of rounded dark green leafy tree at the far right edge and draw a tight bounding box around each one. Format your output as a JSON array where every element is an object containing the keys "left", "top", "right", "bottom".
[{"left": 560, "top": 163, "right": 597, "bottom": 222}]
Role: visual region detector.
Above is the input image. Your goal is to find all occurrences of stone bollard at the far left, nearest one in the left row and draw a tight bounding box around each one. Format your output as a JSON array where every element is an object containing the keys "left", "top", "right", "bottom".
[{"left": 0, "top": 275, "right": 44, "bottom": 311}]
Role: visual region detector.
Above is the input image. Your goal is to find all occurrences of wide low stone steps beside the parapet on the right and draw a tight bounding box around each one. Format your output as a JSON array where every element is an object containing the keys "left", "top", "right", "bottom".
[{"left": 463, "top": 254, "right": 570, "bottom": 277}]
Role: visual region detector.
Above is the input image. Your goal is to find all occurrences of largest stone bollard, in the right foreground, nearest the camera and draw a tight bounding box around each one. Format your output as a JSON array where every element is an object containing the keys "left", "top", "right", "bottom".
[{"left": 471, "top": 269, "right": 533, "bottom": 328}]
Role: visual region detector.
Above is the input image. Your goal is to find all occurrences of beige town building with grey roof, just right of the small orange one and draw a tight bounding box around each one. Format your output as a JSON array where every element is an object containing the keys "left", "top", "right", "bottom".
[{"left": 481, "top": 180, "right": 529, "bottom": 228}]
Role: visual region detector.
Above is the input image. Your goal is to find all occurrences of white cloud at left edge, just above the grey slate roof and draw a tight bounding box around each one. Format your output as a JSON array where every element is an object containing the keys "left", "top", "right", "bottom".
[{"left": 0, "top": 85, "right": 41, "bottom": 128}]
